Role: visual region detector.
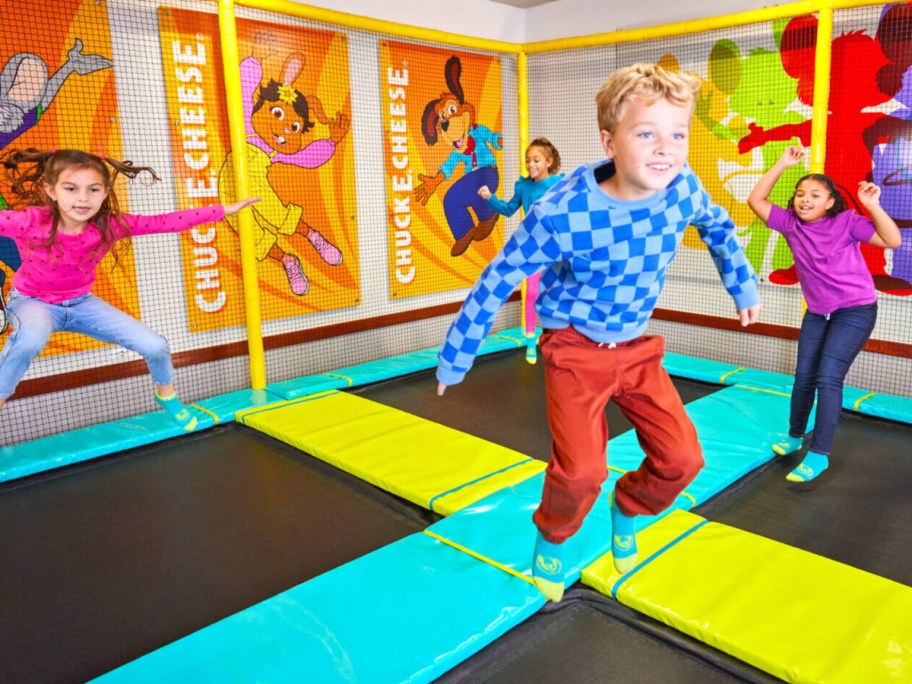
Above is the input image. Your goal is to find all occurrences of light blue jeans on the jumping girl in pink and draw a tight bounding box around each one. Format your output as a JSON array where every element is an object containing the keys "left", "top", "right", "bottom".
[{"left": 0, "top": 290, "right": 174, "bottom": 399}]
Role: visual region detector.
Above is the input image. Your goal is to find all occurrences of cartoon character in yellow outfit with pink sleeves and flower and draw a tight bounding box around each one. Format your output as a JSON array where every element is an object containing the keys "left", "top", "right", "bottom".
[{"left": 219, "top": 32, "right": 351, "bottom": 297}]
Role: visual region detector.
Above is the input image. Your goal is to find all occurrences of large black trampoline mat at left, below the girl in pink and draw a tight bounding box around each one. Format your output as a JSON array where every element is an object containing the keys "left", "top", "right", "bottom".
[{"left": 0, "top": 425, "right": 435, "bottom": 682}]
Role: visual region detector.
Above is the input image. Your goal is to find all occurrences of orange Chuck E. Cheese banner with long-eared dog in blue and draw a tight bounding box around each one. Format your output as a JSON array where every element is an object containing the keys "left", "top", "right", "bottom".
[{"left": 380, "top": 42, "right": 503, "bottom": 299}]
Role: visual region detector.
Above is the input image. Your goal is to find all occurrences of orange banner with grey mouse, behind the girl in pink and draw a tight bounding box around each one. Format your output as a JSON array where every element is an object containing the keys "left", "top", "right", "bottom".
[{"left": 0, "top": 0, "right": 127, "bottom": 356}]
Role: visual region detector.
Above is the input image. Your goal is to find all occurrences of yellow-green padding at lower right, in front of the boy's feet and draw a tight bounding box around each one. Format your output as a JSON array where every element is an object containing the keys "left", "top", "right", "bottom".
[{"left": 582, "top": 510, "right": 912, "bottom": 684}]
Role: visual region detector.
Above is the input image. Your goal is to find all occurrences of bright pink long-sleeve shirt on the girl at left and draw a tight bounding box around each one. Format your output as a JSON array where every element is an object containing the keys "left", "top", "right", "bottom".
[{"left": 0, "top": 204, "right": 225, "bottom": 304}]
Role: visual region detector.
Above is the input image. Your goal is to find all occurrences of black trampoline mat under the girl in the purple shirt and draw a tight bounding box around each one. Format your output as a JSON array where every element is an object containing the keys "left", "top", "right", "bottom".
[{"left": 694, "top": 411, "right": 912, "bottom": 586}]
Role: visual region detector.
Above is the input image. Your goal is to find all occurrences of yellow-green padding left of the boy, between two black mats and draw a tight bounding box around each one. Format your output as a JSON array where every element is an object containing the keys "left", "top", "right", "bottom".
[{"left": 237, "top": 391, "right": 545, "bottom": 515}]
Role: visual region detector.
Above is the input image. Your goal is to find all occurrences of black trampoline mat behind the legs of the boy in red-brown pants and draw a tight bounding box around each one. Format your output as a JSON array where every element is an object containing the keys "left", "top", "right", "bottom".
[{"left": 349, "top": 350, "right": 722, "bottom": 461}]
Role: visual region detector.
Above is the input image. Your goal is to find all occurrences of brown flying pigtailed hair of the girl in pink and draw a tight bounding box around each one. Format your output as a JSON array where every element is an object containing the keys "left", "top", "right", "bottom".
[{"left": 2, "top": 148, "right": 159, "bottom": 265}]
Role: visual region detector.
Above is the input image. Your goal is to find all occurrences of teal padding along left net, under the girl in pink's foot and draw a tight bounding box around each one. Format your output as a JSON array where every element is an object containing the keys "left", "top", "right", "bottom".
[{"left": 0, "top": 390, "right": 279, "bottom": 482}]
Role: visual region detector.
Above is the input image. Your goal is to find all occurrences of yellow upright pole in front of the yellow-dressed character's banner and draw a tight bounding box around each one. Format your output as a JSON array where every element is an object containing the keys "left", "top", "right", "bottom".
[{"left": 218, "top": 0, "right": 266, "bottom": 390}]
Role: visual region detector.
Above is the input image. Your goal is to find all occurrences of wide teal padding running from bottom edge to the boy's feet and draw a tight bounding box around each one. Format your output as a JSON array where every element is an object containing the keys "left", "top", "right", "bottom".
[{"left": 93, "top": 534, "right": 544, "bottom": 684}]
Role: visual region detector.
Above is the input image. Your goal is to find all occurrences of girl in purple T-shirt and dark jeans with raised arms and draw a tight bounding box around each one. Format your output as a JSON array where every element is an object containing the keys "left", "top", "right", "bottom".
[{"left": 747, "top": 146, "right": 901, "bottom": 482}]
